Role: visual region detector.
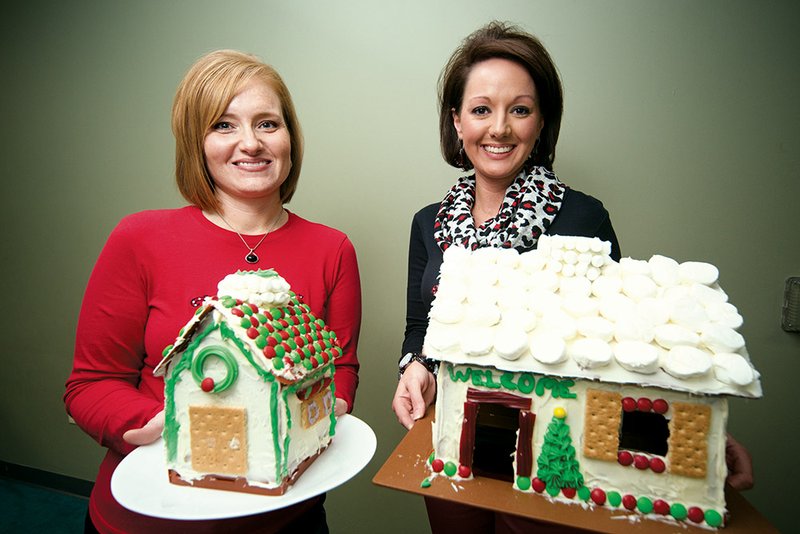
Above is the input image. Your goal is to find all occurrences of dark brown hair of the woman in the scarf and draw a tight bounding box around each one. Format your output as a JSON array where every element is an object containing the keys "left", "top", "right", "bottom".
[{"left": 439, "top": 21, "right": 564, "bottom": 170}]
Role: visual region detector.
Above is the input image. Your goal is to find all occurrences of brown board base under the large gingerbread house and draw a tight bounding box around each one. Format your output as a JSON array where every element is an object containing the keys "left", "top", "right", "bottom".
[{"left": 372, "top": 408, "right": 778, "bottom": 534}]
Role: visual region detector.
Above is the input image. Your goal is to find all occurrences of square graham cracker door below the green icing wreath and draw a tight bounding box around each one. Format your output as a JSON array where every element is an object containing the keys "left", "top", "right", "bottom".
[{"left": 189, "top": 406, "right": 247, "bottom": 475}]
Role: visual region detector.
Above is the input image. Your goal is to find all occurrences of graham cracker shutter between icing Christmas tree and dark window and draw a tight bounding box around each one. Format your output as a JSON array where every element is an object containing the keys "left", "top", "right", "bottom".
[{"left": 583, "top": 389, "right": 622, "bottom": 462}]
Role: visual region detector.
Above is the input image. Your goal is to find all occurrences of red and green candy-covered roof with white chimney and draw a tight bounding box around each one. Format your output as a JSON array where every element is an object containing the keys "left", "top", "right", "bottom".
[{"left": 154, "top": 270, "right": 342, "bottom": 383}]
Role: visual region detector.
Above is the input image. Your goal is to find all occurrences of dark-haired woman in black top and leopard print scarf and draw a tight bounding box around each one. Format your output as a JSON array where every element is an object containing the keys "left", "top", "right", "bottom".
[{"left": 392, "top": 22, "right": 752, "bottom": 533}]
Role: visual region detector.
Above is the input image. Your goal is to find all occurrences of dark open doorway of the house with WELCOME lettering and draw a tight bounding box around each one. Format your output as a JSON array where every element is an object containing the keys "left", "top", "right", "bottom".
[{"left": 472, "top": 403, "right": 519, "bottom": 482}]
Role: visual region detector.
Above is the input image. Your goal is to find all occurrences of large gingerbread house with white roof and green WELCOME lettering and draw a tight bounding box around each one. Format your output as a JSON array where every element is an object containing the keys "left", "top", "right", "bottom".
[{"left": 424, "top": 236, "right": 761, "bottom": 527}]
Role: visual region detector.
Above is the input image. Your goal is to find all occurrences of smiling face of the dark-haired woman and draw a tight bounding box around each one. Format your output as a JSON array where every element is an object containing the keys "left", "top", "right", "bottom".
[{"left": 453, "top": 58, "right": 544, "bottom": 187}]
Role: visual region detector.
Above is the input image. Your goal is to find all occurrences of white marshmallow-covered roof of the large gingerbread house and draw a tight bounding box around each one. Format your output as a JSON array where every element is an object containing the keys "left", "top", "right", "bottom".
[{"left": 423, "top": 236, "right": 761, "bottom": 397}]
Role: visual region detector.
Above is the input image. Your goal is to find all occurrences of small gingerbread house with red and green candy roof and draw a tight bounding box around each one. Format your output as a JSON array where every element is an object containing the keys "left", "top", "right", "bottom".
[{"left": 155, "top": 270, "right": 341, "bottom": 495}]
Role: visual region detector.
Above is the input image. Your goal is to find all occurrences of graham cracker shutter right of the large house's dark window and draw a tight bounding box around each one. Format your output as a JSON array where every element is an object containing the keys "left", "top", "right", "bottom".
[{"left": 668, "top": 402, "right": 711, "bottom": 478}]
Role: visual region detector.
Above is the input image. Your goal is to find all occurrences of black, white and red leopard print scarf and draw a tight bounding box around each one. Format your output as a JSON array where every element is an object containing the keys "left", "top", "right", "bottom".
[{"left": 433, "top": 166, "right": 566, "bottom": 252}]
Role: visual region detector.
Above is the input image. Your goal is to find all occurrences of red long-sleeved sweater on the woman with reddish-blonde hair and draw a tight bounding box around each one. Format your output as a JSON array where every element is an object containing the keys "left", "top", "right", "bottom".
[{"left": 64, "top": 206, "right": 361, "bottom": 534}]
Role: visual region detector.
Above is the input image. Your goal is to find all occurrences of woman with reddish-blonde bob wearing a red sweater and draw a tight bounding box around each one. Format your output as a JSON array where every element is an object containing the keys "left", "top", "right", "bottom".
[{"left": 64, "top": 50, "right": 361, "bottom": 534}]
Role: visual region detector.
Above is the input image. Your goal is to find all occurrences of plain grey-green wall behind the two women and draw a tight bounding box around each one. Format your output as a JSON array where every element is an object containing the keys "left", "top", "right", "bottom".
[{"left": 0, "top": 0, "right": 800, "bottom": 532}]
